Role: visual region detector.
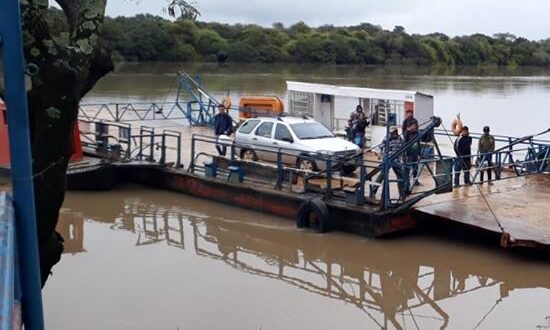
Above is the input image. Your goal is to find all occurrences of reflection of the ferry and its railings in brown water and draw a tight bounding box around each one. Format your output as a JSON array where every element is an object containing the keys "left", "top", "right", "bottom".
[{"left": 59, "top": 196, "right": 550, "bottom": 329}]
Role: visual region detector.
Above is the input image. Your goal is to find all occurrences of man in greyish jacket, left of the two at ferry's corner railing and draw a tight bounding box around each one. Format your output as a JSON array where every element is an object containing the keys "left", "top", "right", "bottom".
[{"left": 370, "top": 127, "right": 408, "bottom": 200}]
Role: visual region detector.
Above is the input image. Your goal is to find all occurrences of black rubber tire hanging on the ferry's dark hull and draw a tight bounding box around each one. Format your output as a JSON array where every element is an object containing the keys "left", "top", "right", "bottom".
[{"left": 296, "top": 199, "right": 330, "bottom": 233}]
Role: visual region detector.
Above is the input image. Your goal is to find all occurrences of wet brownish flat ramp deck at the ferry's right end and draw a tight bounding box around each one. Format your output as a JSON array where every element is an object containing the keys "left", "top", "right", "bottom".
[{"left": 412, "top": 174, "right": 550, "bottom": 247}]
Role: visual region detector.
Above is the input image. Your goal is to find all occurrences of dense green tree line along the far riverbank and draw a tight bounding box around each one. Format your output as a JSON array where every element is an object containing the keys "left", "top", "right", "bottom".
[{"left": 46, "top": 9, "right": 550, "bottom": 66}]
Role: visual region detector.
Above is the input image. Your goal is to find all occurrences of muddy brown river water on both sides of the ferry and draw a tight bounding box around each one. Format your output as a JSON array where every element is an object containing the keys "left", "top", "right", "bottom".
[{"left": 44, "top": 64, "right": 550, "bottom": 329}]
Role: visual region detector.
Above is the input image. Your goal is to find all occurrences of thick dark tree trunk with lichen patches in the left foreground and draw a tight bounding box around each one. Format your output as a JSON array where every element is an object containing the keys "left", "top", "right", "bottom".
[{"left": 21, "top": 0, "right": 113, "bottom": 285}]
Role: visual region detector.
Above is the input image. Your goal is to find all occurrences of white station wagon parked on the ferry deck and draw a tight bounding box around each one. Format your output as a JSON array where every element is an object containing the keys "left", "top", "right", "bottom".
[{"left": 235, "top": 117, "right": 360, "bottom": 175}]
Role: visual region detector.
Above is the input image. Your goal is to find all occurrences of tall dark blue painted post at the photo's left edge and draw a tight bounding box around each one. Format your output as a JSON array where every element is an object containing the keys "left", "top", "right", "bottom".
[{"left": 0, "top": 0, "right": 44, "bottom": 330}]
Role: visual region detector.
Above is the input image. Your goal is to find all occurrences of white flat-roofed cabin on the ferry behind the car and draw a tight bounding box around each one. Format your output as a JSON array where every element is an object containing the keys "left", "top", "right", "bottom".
[{"left": 286, "top": 81, "right": 434, "bottom": 146}]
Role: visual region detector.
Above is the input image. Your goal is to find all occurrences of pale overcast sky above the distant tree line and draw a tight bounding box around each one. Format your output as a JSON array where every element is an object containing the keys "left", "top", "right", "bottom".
[{"left": 107, "top": 0, "right": 550, "bottom": 40}]
